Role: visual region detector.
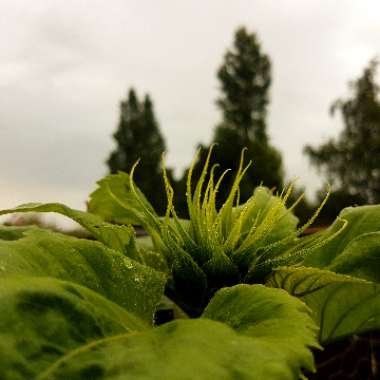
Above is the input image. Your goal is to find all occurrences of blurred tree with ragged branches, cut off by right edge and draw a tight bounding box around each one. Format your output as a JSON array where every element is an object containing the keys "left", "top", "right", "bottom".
[{"left": 305, "top": 60, "right": 380, "bottom": 213}]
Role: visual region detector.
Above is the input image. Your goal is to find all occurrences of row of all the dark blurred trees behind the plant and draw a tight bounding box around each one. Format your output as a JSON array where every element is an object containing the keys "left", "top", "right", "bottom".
[{"left": 107, "top": 27, "right": 380, "bottom": 224}]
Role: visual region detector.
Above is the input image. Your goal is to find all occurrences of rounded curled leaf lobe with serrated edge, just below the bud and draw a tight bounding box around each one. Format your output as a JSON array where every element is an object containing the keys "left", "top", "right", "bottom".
[{"left": 202, "top": 284, "right": 319, "bottom": 369}]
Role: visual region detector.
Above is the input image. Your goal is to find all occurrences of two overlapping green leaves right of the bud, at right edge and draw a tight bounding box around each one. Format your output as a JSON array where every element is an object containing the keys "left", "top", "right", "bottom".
[{"left": 267, "top": 205, "right": 380, "bottom": 343}]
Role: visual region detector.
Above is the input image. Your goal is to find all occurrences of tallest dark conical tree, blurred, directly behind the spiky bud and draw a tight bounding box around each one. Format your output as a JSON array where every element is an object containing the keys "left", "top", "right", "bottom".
[{"left": 177, "top": 27, "right": 283, "bottom": 214}]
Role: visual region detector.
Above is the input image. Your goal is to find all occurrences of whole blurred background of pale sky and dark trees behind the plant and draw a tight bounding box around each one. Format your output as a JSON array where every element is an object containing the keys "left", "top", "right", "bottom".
[{"left": 0, "top": 0, "right": 380, "bottom": 229}]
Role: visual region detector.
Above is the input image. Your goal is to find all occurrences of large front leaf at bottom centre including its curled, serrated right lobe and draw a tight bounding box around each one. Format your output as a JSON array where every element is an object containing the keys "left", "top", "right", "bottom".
[{"left": 24, "top": 285, "right": 316, "bottom": 380}]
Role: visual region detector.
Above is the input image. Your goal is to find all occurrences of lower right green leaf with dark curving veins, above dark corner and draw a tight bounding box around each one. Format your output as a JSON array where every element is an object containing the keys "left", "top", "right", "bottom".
[{"left": 267, "top": 267, "right": 380, "bottom": 344}]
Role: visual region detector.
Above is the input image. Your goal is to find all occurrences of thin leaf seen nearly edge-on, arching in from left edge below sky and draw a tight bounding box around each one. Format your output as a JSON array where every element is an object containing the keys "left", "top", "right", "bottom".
[{"left": 0, "top": 203, "right": 143, "bottom": 262}]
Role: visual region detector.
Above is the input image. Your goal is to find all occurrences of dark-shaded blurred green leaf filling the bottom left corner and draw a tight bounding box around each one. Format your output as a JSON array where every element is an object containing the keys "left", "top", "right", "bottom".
[{"left": 0, "top": 276, "right": 148, "bottom": 380}]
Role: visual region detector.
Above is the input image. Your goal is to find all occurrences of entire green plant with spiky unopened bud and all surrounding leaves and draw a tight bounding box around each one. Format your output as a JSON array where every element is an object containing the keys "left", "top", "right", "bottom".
[{"left": 0, "top": 149, "right": 380, "bottom": 380}]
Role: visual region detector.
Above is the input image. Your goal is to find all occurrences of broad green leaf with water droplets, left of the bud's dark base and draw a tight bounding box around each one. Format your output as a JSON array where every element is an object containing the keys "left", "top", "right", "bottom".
[{"left": 0, "top": 227, "right": 165, "bottom": 321}]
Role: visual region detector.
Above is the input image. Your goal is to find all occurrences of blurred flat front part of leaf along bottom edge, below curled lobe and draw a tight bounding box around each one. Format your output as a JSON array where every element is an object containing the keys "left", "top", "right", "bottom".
[{"left": 36, "top": 319, "right": 306, "bottom": 380}]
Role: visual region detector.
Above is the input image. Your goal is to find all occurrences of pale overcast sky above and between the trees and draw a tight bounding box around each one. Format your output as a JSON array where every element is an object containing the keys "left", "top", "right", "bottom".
[{"left": 0, "top": 0, "right": 380, "bottom": 208}]
